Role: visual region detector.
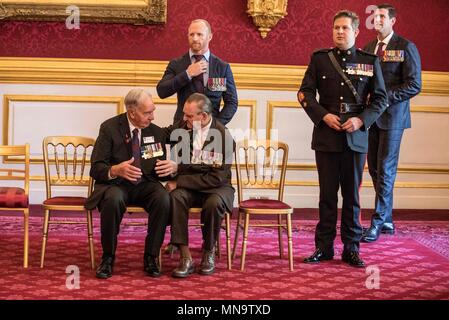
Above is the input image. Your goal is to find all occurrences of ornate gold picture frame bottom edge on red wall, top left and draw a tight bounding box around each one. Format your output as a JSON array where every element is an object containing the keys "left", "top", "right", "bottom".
[{"left": 0, "top": 0, "right": 167, "bottom": 25}]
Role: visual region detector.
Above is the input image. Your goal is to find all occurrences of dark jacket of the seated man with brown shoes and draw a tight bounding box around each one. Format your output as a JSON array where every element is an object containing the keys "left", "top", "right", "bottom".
[{"left": 166, "top": 118, "right": 235, "bottom": 212}]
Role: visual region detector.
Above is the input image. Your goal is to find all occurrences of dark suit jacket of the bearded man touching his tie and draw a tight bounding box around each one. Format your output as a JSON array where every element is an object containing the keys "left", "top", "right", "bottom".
[{"left": 156, "top": 52, "right": 238, "bottom": 125}]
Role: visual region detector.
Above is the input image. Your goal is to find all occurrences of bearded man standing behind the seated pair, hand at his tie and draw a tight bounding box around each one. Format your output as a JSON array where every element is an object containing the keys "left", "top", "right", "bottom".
[{"left": 157, "top": 19, "right": 238, "bottom": 125}]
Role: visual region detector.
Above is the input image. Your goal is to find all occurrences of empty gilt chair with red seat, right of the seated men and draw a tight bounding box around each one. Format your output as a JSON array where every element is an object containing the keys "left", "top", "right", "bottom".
[{"left": 233, "top": 140, "right": 293, "bottom": 271}]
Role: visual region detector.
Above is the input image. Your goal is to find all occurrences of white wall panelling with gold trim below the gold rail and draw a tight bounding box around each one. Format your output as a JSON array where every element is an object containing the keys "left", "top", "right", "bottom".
[{"left": 0, "top": 84, "right": 449, "bottom": 209}]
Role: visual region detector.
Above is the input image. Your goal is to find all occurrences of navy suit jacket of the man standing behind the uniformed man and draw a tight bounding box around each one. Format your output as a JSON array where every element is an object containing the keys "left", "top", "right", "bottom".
[{"left": 364, "top": 33, "right": 422, "bottom": 130}]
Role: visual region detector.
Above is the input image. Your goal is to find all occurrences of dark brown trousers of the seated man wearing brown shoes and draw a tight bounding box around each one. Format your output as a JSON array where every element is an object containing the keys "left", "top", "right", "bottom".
[{"left": 170, "top": 188, "right": 226, "bottom": 251}]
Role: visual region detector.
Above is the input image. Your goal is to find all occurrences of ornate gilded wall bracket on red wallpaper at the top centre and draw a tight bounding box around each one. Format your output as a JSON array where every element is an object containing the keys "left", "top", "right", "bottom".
[{"left": 246, "top": 0, "right": 288, "bottom": 38}]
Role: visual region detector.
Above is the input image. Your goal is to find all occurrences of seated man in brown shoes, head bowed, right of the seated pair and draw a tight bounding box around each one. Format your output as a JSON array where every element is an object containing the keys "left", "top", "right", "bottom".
[{"left": 166, "top": 93, "right": 235, "bottom": 278}]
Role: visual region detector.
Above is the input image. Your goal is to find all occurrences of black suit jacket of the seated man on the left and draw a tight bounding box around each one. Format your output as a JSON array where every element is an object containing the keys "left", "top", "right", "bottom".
[{"left": 85, "top": 113, "right": 166, "bottom": 210}]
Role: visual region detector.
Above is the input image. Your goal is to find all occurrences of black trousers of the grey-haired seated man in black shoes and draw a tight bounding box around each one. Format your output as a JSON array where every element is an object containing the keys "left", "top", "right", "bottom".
[{"left": 98, "top": 181, "right": 170, "bottom": 257}]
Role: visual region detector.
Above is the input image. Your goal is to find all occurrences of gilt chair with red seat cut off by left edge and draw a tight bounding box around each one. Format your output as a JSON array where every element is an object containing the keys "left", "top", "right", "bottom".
[{"left": 0, "top": 144, "right": 30, "bottom": 268}]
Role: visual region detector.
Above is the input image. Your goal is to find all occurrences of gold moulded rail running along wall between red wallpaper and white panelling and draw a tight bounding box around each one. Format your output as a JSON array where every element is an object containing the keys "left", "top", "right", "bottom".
[{"left": 0, "top": 57, "right": 449, "bottom": 96}]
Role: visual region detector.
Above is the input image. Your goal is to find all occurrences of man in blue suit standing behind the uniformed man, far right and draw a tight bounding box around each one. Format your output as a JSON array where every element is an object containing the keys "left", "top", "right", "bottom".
[{"left": 362, "top": 4, "right": 421, "bottom": 242}]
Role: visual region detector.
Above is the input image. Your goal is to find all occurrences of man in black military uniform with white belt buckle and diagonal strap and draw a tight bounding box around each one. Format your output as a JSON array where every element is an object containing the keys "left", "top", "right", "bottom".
[{"left": 298, "top": 10, "right": 387, "bottom": 267}]
